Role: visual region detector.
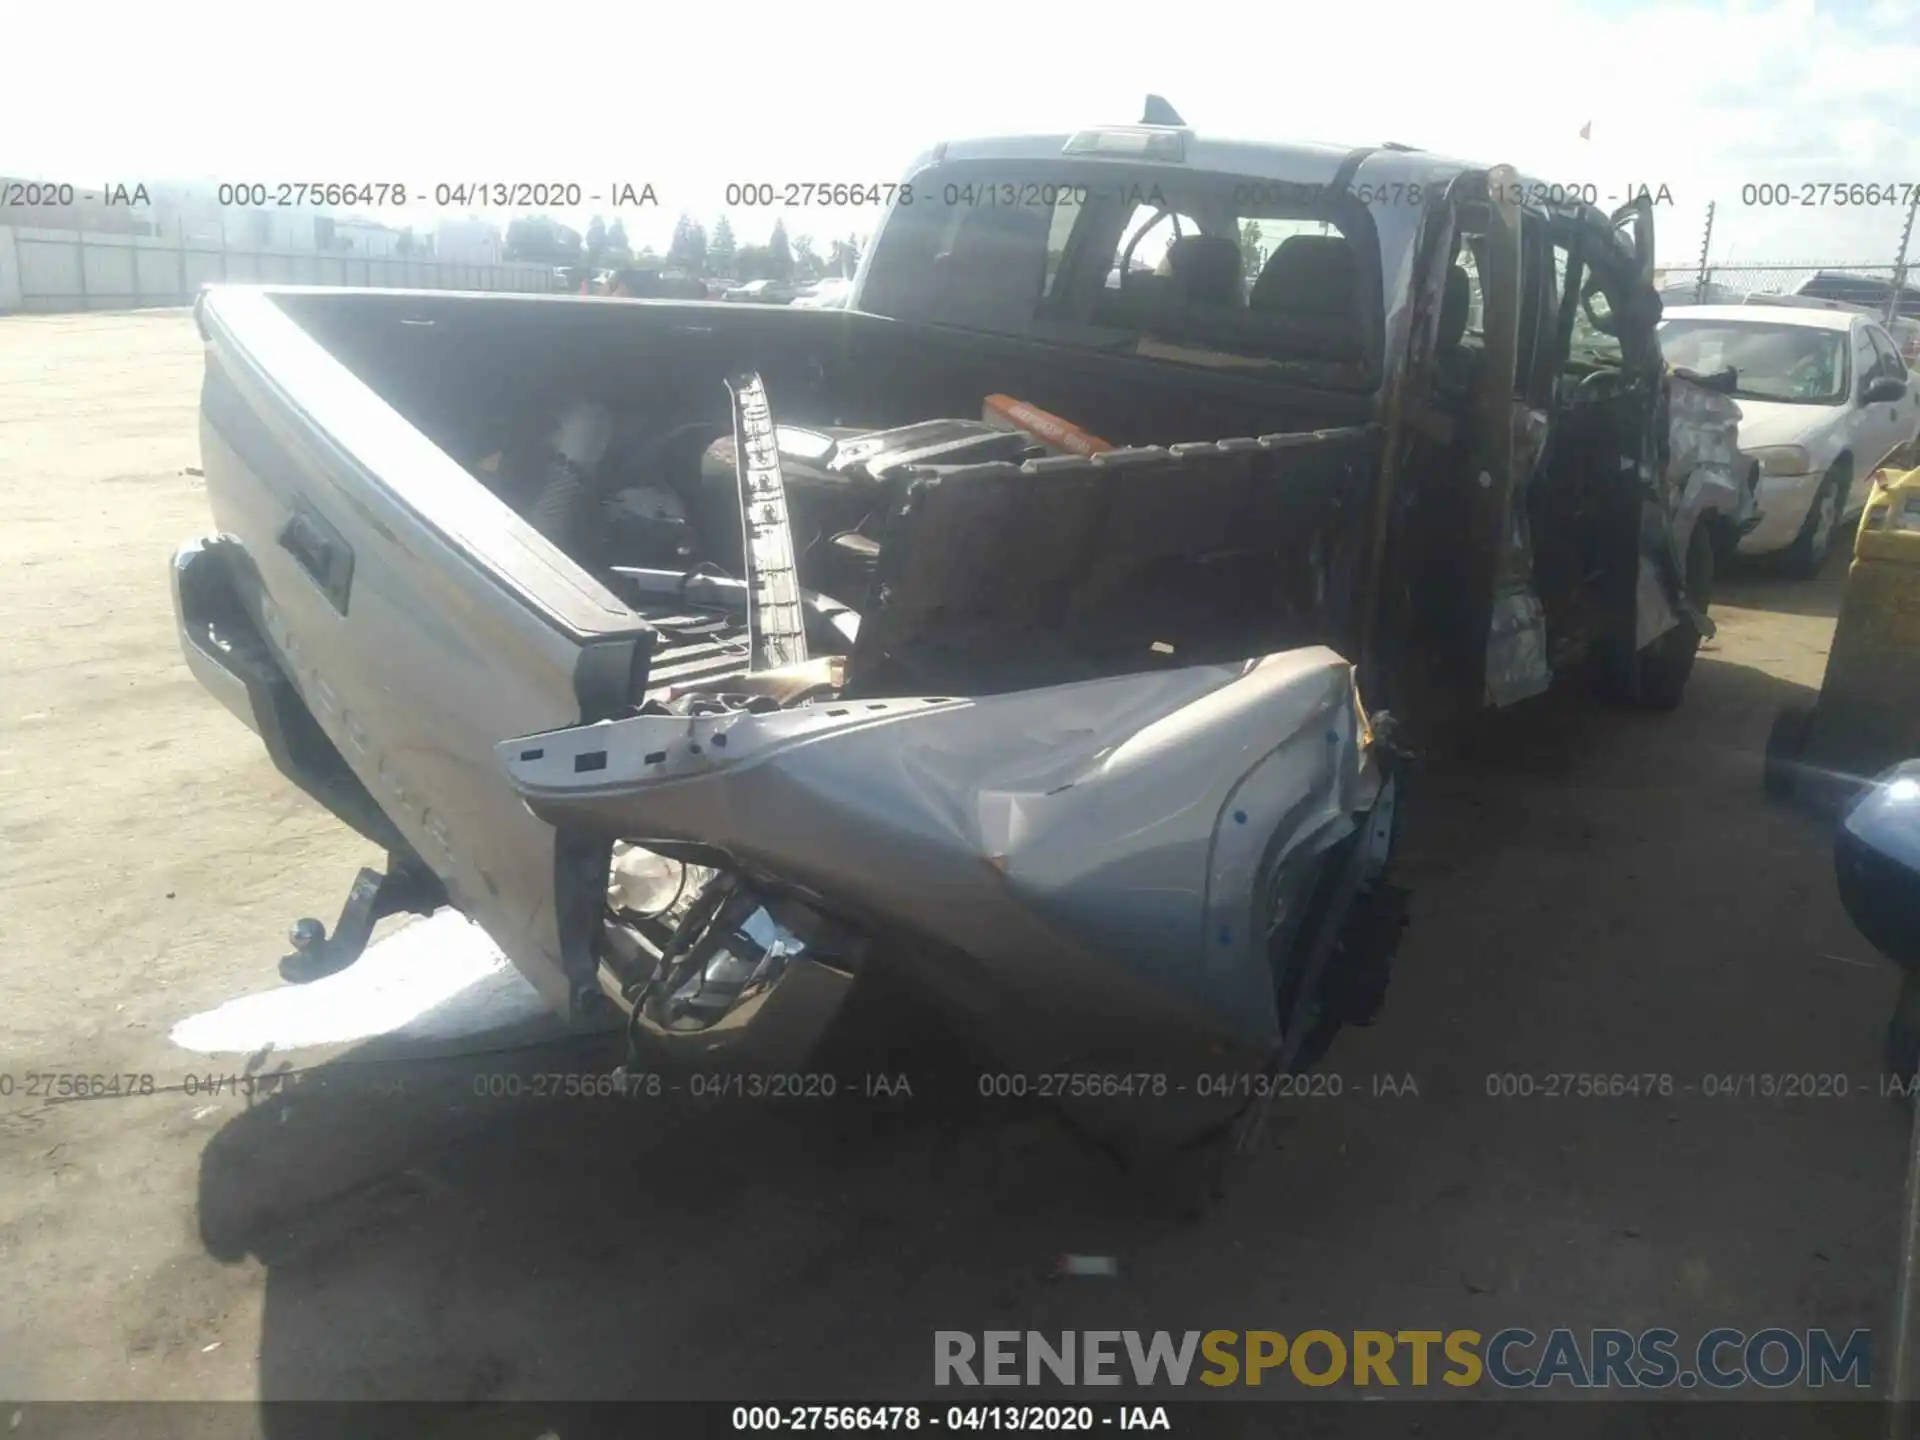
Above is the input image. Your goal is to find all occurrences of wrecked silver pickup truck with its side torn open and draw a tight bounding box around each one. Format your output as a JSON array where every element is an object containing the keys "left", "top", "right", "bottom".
[{"left": 173, "top": 125, "right": 1741, "bottom": 1148}]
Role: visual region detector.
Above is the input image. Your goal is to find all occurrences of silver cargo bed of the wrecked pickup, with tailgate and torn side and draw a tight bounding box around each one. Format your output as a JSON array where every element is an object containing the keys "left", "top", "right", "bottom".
[{"left": 177, "top": 288, "right": 1382, "bottom": 1144}]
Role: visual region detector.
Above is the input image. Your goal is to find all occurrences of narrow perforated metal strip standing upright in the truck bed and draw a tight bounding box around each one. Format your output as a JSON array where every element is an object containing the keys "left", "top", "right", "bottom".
[{"left": 728, "top": 374, "right": 806, "bottom": 670}]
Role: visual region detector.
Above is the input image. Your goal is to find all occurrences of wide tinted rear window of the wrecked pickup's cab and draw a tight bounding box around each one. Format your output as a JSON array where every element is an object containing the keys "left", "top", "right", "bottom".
[{"left": 862, "top": 161, "right": 1380, "bottom": 390}]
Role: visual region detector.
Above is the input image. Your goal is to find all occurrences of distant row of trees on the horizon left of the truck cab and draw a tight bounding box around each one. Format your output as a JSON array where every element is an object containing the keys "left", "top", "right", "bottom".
[{"left": 505, "top": 215, "right": 860, "bottom": 282}]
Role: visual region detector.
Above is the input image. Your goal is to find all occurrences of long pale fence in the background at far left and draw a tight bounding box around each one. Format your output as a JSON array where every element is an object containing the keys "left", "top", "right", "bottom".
[{"left": 0, "top": 225, "right": 553, "bottom": 315}]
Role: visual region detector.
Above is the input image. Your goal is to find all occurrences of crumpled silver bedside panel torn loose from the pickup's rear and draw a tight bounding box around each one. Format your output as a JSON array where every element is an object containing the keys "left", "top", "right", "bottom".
[{"left": 499, "top": 647, "right": 1380, "bottom": 1052}]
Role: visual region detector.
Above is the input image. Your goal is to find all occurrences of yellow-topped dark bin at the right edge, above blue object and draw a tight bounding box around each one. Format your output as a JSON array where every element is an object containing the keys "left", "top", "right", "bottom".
[{"left": 1764, "top": 468, "right": 1920, "bottom": 801}]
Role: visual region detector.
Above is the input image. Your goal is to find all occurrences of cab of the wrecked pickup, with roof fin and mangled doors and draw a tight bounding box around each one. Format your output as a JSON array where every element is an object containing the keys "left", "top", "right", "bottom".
[{"left": 849, "top": 125, "right": 1751, "bottom": 712}]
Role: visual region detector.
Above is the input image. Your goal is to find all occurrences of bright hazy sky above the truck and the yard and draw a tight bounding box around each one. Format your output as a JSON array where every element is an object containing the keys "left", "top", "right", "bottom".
[{"left": 0, "top": 0, "right": 1920, "bottom": 263}]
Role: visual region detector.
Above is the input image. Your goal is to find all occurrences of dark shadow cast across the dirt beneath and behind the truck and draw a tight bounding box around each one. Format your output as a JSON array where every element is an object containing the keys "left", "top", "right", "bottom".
[{"left": 200, "top": 659, "right": 1905, "bottom": 1434}]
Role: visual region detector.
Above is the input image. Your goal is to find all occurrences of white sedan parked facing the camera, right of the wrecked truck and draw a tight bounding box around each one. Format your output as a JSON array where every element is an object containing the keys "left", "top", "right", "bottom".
[{"left": 1659, "top": 307, "right": 1920, "bottom": 576}]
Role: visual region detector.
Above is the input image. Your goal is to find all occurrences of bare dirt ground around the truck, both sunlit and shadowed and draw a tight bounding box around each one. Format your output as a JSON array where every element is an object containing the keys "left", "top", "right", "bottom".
[{"left": 0, "top": 311, "right": 1907, "bottom": 1400}]
